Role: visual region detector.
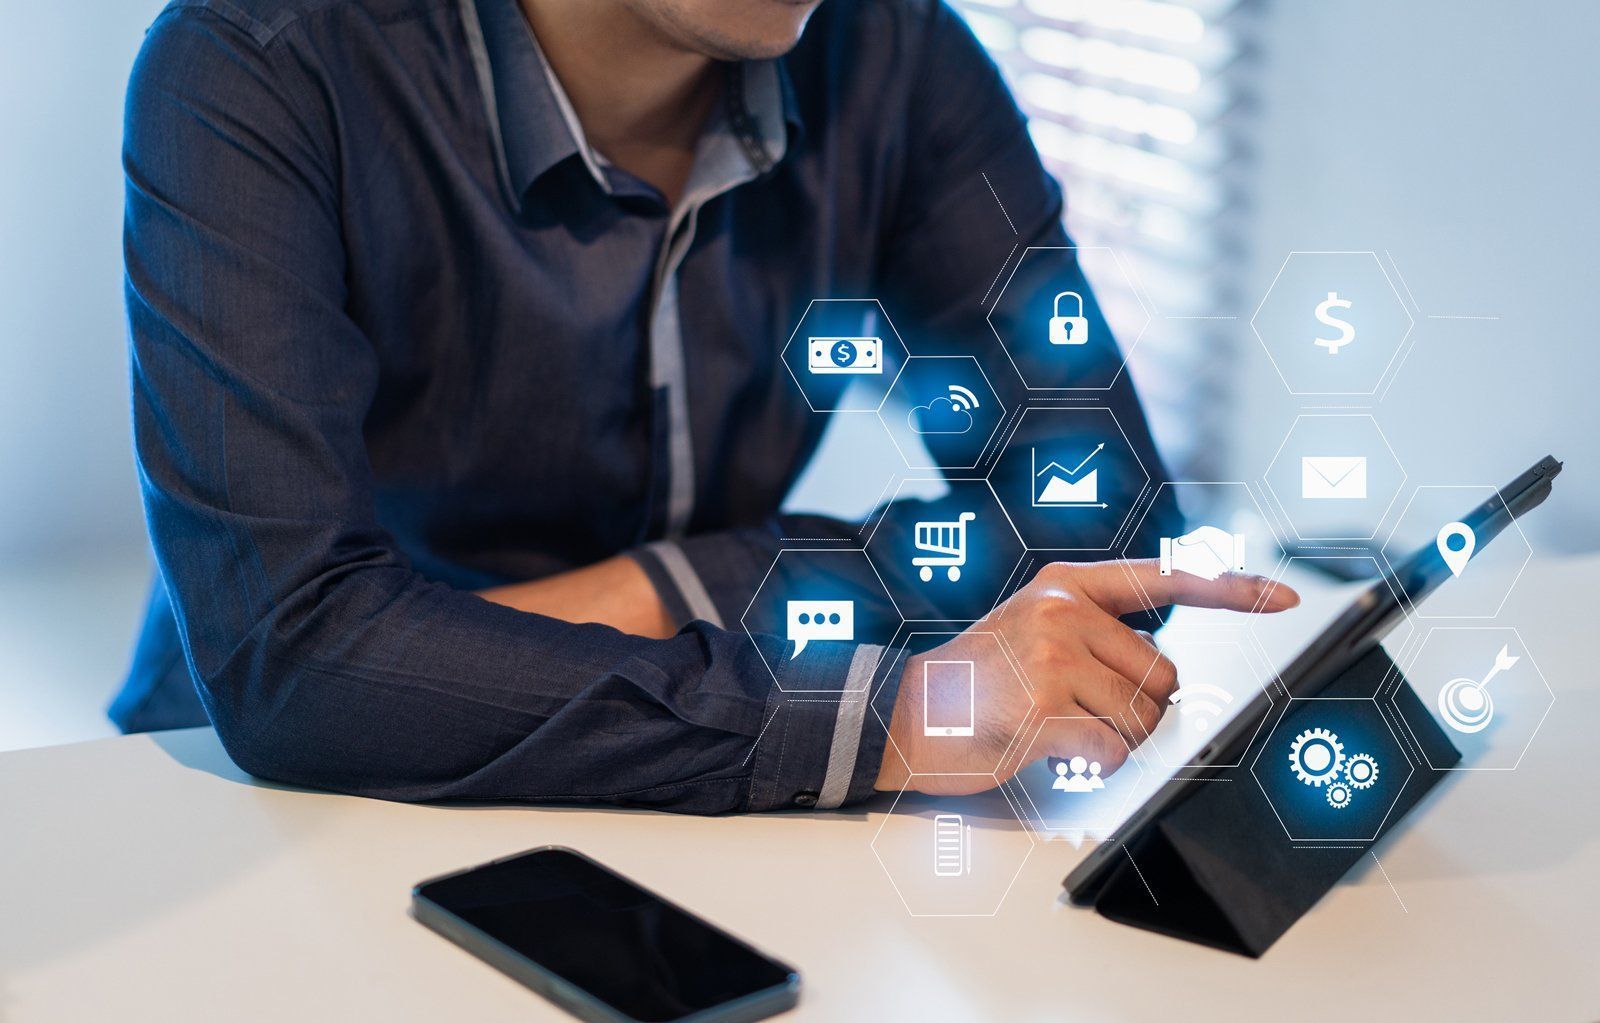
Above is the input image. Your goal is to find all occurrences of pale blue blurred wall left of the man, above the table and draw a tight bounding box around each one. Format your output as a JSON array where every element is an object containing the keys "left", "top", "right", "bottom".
[{"left": 0, "top": 0, "right": 160, "bottom": 749}]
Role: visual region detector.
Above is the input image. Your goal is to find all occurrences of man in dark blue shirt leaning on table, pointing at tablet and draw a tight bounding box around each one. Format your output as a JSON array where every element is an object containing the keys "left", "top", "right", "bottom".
[{"left": 112, "top": 0, "right": 1293, "bottom": 813}]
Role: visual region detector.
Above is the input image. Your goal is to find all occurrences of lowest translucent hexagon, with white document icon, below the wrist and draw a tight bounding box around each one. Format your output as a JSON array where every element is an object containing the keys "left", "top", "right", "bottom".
[{"left": 870, "top": 775, "right": 1034, "bottom": 916}]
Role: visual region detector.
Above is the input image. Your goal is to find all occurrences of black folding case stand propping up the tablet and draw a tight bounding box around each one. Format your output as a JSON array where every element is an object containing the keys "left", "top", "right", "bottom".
[{"left": 1094, "top": 647, "right": 1461, "bottom": 957}]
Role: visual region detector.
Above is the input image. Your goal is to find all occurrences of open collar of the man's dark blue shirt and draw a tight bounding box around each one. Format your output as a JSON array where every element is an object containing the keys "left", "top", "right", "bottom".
[{"left": 459, "top": 0, "right": 800, "bottom": 205}]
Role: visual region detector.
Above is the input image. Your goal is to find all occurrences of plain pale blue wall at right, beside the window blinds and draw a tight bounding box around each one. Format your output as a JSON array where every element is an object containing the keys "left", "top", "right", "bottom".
[{"left": 1235, "top": 0, "right": 1600, "bottom": 551}]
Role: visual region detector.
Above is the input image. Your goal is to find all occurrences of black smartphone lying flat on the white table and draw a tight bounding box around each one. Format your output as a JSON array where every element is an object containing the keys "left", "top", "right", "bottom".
[{"left": 411, "top": 845, "right": 800, "bottom": 1023}]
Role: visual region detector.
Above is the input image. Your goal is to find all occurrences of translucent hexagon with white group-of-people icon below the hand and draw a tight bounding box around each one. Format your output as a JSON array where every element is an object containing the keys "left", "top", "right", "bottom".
[{"left": 1006, "top": 714, "right": 1150, "bottom": 837}]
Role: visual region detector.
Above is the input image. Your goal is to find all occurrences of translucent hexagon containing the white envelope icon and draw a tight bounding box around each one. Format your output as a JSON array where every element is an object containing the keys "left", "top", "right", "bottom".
[{"left": 1266, "top": 413, "right": 1406, "bottom": 540}]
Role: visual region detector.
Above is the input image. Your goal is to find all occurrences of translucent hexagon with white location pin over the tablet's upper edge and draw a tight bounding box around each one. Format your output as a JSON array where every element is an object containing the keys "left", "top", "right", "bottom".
[{"left": 1382, "top": 483, "right": 1533, "bottom": 620}]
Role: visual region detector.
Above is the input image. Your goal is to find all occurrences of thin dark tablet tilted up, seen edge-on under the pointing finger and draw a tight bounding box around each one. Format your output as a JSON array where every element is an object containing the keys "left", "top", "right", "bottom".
[{"left": 1062, "top": 456, "right": 1562, "bottom": 906}]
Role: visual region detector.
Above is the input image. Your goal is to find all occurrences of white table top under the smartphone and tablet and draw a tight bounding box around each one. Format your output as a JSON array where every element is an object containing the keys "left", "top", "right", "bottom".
[{"left": 0, "top": 560, "right": 1600, "bottom": 1023}]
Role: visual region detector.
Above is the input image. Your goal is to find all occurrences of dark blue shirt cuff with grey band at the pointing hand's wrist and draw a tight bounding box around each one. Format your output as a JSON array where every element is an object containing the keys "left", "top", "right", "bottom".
[{"left": 749, "top": 644, "right": 904, "bottom": 810}]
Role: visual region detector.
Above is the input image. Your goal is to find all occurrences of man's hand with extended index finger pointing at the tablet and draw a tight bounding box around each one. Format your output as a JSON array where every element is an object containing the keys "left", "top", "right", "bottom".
[{"left": 877, "top": 559, "right": 1299, "bottom": 794}]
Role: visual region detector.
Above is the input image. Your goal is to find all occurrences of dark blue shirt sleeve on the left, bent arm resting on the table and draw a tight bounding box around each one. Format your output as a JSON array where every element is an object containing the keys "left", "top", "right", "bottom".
[{"left": 125, "top": 6, "right": 883, "bottom": 813}]
